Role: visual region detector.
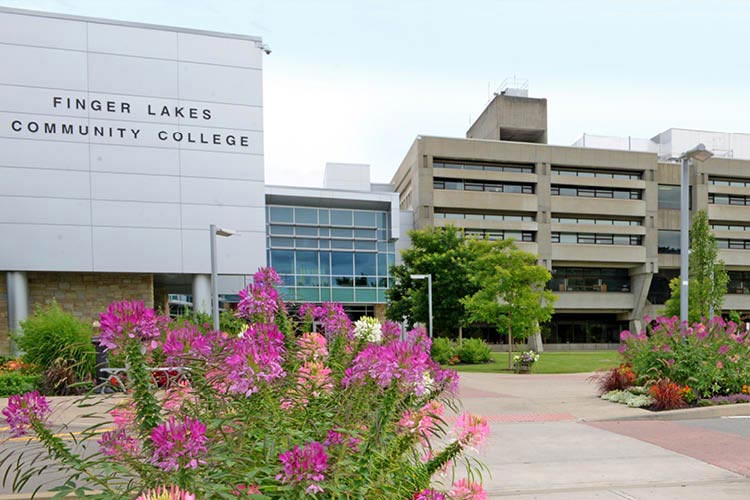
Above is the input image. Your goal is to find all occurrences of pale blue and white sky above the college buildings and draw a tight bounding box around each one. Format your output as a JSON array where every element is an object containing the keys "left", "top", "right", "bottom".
[{"left": 0, "top": 0, "right": 750, "bottom": 186}]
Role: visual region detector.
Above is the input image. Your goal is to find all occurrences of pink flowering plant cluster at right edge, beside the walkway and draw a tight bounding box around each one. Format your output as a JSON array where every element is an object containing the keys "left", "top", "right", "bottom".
[{"left": 620, "top": 317, "right": 750, "bottom": 403}]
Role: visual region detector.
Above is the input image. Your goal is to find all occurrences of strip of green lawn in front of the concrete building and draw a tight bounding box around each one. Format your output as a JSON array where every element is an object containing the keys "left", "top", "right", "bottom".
[{"left": 451, "top": 351, "right": 621, "bottom": 373}]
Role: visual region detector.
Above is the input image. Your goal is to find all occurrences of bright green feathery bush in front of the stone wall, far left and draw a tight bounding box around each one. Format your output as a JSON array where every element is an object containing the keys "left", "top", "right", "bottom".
[{"left": 14, "top": 301, "right": 96, "bottom": 381}]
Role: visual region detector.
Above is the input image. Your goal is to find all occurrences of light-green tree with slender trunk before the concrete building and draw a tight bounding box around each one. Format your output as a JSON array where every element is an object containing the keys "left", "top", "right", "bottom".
[{"left": 462, "top": 240, "right": 557, "bottom": 368}]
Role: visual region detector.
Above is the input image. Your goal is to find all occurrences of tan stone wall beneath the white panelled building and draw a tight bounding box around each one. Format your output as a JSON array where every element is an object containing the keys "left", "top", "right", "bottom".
[{"left": 0, "top": 272, "right": 154, "bottom": 354}]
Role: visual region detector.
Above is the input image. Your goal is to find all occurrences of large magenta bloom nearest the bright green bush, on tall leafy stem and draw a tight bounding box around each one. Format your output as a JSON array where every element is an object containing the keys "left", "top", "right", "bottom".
[{"left": 99, "top": 300, "right": 160, "bottom": 353}]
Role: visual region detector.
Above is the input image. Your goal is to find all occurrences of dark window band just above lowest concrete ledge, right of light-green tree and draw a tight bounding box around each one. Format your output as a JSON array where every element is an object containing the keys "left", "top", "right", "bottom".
[{"left": 547, "top": 267, "right": 630, "bottom": 293}]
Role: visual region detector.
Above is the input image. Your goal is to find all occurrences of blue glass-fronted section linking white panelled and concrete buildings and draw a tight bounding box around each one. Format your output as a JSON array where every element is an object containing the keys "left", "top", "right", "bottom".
[{"left": 266, "top": 163, "right": 402, "bottom": 318}]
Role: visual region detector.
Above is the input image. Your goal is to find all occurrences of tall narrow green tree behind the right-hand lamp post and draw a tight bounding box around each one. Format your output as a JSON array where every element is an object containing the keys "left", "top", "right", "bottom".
[{"left": 664, "top": 210, "right": 729, "bottom": 323}]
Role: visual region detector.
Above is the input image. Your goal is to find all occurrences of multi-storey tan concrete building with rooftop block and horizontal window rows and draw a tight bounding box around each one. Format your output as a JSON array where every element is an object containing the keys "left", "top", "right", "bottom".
[{"left": 392, "top": 88, "right": 750, "bottom": 344}]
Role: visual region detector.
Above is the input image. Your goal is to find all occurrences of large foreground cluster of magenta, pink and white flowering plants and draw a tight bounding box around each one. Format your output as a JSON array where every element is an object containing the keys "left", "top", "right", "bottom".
[{"left": 0, "top": 269, "right": 489, "bottom": 500}]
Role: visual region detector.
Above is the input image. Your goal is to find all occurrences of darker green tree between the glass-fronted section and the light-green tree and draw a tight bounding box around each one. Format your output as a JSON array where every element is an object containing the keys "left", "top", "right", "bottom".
[{"left": 386, "top": 226, "right": 476, "bottom": 334}]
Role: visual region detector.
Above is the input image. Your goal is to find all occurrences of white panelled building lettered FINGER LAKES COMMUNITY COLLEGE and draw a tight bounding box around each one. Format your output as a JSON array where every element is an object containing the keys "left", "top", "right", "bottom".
[{"left": 0, "top": 8, "right": 265, "bottom": 354}]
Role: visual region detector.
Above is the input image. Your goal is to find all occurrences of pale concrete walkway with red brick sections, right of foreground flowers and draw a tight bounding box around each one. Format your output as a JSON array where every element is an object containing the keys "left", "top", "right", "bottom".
[{"left": 460, "top": 373, "right": 750, "bottom": 500}]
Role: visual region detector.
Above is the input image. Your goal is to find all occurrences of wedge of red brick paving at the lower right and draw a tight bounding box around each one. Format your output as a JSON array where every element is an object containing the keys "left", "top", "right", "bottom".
[{"left": 587, "top": 420, "right": 750, "bottom": 474}]
